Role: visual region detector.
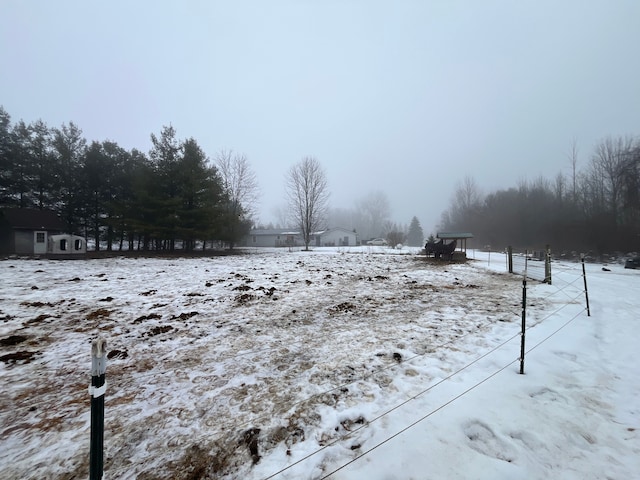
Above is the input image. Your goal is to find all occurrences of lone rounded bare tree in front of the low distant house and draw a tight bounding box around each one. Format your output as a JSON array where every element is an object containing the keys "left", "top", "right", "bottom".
[{"left": 286, "top": 157, "right": 329, "bottom": 250}]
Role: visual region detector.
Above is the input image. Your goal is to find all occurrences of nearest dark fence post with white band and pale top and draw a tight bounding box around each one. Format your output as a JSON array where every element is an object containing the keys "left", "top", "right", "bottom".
[{"left": 89, "top": 338, "right": 107, "bottom": 480}]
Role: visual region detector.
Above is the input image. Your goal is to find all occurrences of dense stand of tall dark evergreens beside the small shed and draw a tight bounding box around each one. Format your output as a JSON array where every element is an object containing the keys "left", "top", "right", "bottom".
[{"left": 0, "top": 106, "right": 254, "bottom": 250}]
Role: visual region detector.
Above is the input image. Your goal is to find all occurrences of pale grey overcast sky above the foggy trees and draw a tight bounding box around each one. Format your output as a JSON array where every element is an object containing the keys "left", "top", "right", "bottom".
[{"left": 0, "top": 0, "right": 640, "bottom": 233}]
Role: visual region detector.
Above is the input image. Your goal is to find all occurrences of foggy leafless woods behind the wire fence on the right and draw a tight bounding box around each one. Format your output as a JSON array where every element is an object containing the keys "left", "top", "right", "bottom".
[{"left": 441, "top": 137, "right": 640, "bottom": 255}]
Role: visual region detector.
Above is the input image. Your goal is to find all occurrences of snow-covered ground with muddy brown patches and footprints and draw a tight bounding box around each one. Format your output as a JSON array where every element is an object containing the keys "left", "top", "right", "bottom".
[{"left": 0, "top": 247, "right": 640, "bottom": 480}]
